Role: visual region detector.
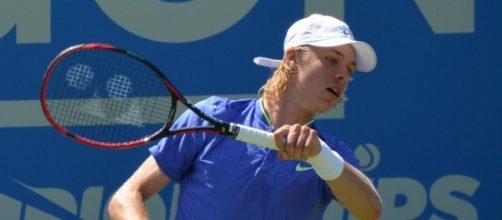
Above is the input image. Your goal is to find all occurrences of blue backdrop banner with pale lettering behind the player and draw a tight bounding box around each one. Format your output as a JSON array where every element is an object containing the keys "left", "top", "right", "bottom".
[{"left": 0, "top": 0, "right": 502, "bottom": 220}]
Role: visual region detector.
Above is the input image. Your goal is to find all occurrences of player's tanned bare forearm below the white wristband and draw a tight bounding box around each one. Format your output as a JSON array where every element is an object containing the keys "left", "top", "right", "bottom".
[{"left": 327, "top": 163, "right": 382, "bottom": 219}]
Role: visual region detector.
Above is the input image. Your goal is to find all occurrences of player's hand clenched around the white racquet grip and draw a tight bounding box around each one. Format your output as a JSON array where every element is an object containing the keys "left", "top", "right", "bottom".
[{"left": 274, "top": 124, "right": 321, "bottom": 160}]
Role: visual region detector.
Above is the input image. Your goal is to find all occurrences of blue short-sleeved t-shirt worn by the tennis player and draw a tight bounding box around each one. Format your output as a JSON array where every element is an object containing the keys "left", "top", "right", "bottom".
[{"left": 150, "top": 96, "right": 358, "bottom": 220}]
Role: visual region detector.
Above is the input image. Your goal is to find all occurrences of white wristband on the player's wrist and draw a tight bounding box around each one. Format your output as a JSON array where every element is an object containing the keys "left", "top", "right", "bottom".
[{"left": 307, "top": 141, "right": 345, "bottom": 180}]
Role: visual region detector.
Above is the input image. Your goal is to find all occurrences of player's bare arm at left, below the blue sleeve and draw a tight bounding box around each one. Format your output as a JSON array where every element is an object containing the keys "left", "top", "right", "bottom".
[{"left": 108, "top": 156, "right": 170, "bottom": 219}]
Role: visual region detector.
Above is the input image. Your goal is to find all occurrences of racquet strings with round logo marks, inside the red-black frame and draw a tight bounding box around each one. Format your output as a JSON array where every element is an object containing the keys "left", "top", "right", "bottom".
[{"left": 46, "top": 49, "right": 176, "bottom": 144}]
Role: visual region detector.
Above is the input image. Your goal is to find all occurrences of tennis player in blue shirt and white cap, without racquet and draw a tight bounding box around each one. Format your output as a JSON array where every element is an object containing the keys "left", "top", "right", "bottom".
[{"left": 108, "top": 14, "right": 381, "bottom": 220}]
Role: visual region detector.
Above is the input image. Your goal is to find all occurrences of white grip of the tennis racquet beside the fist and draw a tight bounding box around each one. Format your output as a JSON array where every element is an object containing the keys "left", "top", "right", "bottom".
[{"left": 230, "top": 123, "right": 279, "bottom": 150}]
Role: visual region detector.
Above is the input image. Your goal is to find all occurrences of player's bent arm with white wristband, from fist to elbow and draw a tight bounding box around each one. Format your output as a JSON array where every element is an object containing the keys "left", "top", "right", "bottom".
[{"left": 274, "top": 124, "right": 382, "bottom": 220}]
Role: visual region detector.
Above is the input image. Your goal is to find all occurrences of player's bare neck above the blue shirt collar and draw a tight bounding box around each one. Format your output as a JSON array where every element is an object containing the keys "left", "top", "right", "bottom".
[{"left": 262, "top": 98, "right": 314, "bottom": 128}]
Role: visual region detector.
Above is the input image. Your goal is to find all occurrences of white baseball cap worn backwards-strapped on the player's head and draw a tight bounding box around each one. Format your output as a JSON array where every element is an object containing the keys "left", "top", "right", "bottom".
[{"left": 253, "top": 14, "right": 377, "bottom": 72}]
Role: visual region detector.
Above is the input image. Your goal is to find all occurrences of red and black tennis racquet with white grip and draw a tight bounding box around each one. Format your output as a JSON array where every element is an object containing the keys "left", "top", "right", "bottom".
[{"left": 40, "top": 43, "right": 277, "bottom": 149}]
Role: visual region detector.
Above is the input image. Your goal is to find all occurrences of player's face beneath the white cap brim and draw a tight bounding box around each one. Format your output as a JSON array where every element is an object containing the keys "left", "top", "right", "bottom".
[{"left": 288, "top": 45, "right": 355, "bottom": 113}]
